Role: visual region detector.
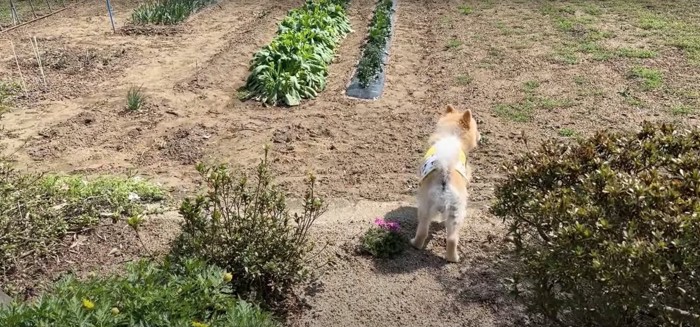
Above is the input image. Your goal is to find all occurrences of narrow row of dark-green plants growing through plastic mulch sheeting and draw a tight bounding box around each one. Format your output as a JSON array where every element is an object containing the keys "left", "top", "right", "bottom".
[{"left": 357, "top": 0, "right": 394, "bottom": 87}]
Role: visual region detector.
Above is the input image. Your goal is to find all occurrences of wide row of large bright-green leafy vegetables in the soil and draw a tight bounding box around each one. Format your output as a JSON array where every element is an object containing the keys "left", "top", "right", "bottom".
[{"left": 243, "top": 0, "right": 351, "bottom": 106}]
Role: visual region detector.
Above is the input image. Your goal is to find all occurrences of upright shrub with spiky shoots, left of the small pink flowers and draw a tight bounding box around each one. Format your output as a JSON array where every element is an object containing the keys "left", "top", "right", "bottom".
[{"left": 174, "top": 152, "right": 324, "bottom": 309}]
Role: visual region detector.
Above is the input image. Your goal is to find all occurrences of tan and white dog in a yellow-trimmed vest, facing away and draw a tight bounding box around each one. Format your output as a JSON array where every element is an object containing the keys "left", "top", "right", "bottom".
[{"left": 411, "top": 105, "right": 481, "bottom": 262}]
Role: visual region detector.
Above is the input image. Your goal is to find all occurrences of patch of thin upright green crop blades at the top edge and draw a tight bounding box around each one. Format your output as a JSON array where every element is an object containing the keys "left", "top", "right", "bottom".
[{"left": 131, "top": 0, "right": 216, "bottom": 25}]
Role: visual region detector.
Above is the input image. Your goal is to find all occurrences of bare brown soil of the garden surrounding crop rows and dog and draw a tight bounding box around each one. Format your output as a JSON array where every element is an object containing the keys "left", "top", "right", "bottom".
[{"left": 0, "top": 0, "right": 700, "bottom": 326}]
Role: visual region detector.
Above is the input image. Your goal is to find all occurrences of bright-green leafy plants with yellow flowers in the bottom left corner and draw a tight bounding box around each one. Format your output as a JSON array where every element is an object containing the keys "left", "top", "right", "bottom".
[{"left": 0, "top": 260, "right": 278, "bottom": 327}]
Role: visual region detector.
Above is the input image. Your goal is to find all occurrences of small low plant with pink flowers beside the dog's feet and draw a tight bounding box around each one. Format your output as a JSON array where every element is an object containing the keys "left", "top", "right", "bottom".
[{"left": 360, "top": 218, "right": 407, "bottom": 258}]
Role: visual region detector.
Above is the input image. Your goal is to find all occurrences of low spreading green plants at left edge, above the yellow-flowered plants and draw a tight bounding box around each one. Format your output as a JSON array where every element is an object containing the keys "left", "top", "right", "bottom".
[{"left": 0, "top": 160, "right": 165, "bottom": 290}]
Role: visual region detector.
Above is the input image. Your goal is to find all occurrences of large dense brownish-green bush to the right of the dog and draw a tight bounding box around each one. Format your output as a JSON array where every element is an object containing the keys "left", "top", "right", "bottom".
[{"left": 492, "top": 123, "right": 700, "bottom": 326}]
